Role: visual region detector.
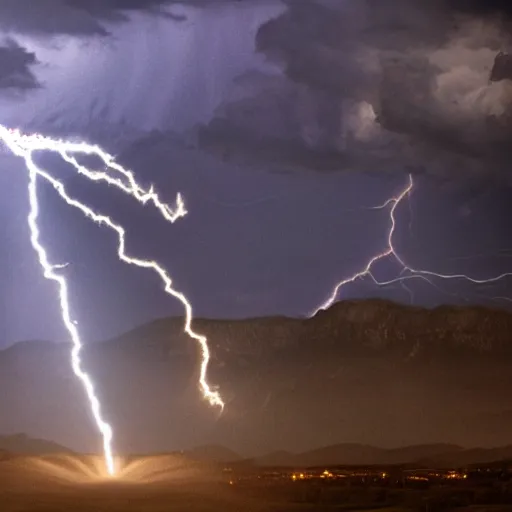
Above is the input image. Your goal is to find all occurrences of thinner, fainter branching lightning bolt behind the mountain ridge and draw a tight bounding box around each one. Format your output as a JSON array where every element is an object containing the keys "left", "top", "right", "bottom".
[{"left": 310, "top": 174, "right": 512, "bottom": 317}]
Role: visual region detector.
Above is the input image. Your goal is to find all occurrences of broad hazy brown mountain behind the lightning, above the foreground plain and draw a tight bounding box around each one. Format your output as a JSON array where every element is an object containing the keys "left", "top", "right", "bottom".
[{"left": 0, "top": 300, "right": 512, "bottom": 452}]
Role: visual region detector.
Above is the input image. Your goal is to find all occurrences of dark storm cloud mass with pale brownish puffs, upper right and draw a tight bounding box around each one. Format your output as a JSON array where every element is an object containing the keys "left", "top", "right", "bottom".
[{"left": 199, "top": 0, "right": 512, "bottom": 180}]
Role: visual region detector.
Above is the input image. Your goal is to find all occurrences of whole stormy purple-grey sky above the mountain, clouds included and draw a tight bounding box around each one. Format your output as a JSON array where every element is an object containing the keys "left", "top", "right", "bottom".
[{"left": 0, "top": 0, "right": 512, "bottom": 347}]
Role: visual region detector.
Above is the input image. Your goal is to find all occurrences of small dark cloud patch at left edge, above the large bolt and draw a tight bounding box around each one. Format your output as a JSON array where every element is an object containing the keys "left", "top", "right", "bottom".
[{"left": 0, "top": 40, "right": 39, "bottom": 90}]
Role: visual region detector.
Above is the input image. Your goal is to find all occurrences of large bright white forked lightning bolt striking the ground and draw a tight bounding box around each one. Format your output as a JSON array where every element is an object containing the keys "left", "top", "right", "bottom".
[{"left": 0, "top": 124, "right": 224, "bottom": 475}]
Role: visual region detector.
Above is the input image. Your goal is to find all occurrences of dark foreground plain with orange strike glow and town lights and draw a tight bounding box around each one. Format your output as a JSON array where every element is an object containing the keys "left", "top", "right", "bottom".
[{"left": 5, "top": 454, "right": 512, "bottom": 512}]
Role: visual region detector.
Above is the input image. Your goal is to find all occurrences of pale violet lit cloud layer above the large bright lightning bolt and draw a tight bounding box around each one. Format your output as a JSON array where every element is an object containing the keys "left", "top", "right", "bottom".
[{"left": 0, "top": 0, "right": 284, "bottom": 137}]
